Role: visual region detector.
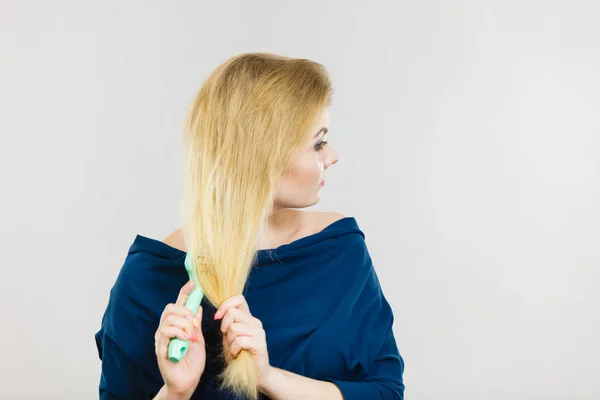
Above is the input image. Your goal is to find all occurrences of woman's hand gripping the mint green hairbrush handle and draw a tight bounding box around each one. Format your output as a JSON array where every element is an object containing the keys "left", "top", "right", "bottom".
[{"left": 154, "top": 281, "right": 206, "bottom": 398}]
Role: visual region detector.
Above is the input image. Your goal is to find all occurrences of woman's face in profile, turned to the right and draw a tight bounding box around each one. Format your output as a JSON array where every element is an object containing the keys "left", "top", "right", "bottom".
[{"left": 275, "top": 110, "right": 338, "bottom": 209}]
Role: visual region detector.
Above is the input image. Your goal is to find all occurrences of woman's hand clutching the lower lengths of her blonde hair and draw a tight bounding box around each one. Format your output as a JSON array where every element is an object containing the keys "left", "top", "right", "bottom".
[{"left": 215, "top": 294, "right": 271, "bottom": 380}]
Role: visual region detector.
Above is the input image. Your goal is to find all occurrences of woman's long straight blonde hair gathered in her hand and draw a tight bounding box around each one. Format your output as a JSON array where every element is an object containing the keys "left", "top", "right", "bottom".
[{"left": 181, "top": 53, "right": 333, "bottom": 399}]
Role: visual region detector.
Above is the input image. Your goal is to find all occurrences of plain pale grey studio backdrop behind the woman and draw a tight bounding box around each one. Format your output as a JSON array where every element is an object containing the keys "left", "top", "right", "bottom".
[{"left": 0, "top": 0, "right": 600, "bottom": 400}]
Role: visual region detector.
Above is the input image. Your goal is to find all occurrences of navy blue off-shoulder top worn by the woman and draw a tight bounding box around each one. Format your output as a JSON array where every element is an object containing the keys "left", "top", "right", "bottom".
[{"left": 95, "top": 217, "right": 404, "bottom": 400}]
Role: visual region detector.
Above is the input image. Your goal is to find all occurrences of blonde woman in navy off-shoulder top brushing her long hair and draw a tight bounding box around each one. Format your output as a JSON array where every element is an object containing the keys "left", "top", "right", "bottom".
[{"left": 96, "top": 53, "right": 404, "bottom": 400}]
